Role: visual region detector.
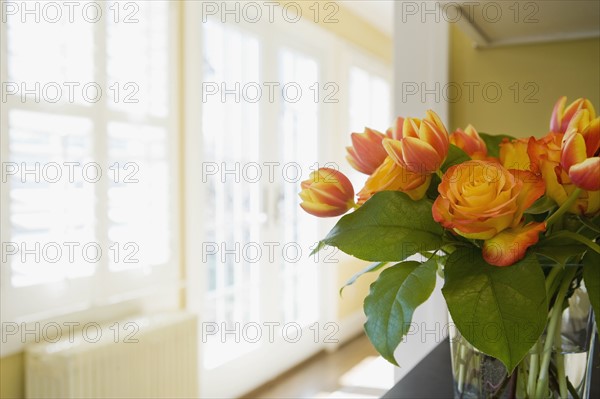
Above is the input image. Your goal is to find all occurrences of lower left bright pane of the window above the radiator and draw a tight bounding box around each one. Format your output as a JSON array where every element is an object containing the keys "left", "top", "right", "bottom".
[{"left": 8, "top": 110, "right": 99, "bottom": 286}]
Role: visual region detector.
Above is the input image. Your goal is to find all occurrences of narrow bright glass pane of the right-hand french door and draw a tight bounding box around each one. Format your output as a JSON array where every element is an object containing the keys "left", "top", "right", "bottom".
[{"left": 278, "top": 49, "right": 322, "bottom": 325}]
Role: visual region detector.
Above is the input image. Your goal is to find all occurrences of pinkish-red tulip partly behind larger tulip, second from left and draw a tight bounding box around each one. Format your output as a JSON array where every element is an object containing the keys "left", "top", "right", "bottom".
[{"left": 346, "top": 128, "right": 387, "bottom": 175}]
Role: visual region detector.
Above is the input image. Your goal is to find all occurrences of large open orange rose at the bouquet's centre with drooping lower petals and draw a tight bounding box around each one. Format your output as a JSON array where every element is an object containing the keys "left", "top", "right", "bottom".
[{"left": 432, "top": 160, "right": 544, "bottom": 266}]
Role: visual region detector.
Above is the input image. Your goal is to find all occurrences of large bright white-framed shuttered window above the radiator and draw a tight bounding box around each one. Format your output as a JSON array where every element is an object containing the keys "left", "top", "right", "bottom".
[{"left": 0, "top": 1, "right": 178, "bottom": 354}]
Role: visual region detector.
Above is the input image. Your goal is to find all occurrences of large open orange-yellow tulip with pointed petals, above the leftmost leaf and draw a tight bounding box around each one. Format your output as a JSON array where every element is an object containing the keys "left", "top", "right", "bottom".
[{"left": 383, "top": 110, "right": 450, "bottom": 174}]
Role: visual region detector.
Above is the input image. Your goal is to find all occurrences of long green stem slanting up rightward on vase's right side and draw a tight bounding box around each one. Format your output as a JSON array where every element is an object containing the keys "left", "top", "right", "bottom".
[{"left": 535, "top": 267, "right": 577, "bottom": 398}]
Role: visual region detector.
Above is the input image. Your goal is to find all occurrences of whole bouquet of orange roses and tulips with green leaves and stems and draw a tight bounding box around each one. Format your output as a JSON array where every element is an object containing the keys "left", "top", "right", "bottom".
[{"left": 299, "top": 97, "right": 600, "bottom": 397}]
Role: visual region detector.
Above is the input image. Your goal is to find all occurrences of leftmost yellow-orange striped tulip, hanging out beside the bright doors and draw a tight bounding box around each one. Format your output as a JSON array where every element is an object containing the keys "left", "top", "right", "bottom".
[{"left": 299, "top": 168, "right": 354, "bottom": 217}]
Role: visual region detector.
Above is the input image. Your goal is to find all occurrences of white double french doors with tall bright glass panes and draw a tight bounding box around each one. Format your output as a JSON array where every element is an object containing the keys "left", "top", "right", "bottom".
[{"left": 186, "top": 9, "right": 336, "bottom": 397}]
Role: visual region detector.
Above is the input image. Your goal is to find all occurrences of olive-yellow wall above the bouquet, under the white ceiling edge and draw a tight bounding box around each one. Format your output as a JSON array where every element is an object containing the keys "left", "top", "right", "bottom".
[{"left": 447, "top": 26, "right": 600, "bottom": 136}]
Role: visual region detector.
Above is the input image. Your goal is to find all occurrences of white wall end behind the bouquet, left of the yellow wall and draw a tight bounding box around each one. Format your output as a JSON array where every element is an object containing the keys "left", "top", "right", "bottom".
[{"left": 393, "top": 1, "right": 449, "bottom": 381}]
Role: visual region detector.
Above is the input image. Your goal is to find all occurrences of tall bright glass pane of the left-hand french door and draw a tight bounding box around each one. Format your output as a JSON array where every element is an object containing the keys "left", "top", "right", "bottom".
[{"left": 202, "top": 22, "right": 265, "bottom": 368}]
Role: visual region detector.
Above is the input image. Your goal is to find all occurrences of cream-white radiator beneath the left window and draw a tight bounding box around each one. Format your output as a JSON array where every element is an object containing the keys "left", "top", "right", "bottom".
[{"left": 25, "top": 312, "right": 198, "bottom": 399}]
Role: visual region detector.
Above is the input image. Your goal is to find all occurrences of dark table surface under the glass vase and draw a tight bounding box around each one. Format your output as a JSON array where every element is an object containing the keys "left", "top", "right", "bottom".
[{"left": 383, "top": 336, "right": 600, "bottom": 399}]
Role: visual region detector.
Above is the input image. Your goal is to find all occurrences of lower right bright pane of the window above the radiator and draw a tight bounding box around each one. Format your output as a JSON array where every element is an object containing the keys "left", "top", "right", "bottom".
[{"left": 107, "top": 122, "right": 170, "bottom": 271}]
